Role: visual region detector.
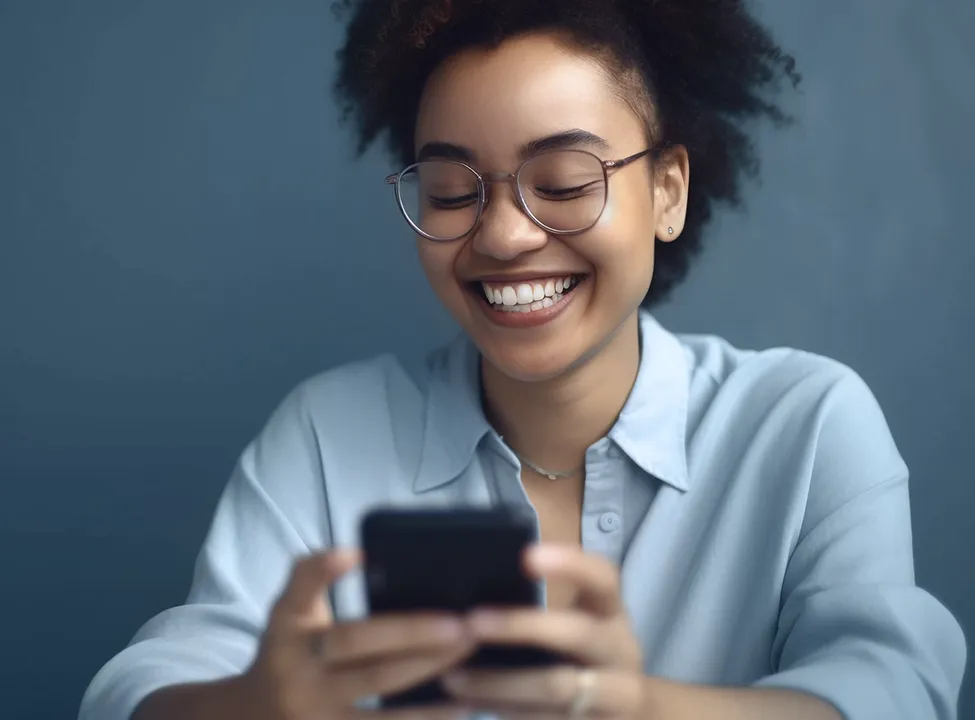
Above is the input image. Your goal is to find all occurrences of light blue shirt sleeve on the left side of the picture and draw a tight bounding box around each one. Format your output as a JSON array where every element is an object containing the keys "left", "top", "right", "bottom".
[{"left": 79, "top": 391, "right": 330, "bottom": 720}]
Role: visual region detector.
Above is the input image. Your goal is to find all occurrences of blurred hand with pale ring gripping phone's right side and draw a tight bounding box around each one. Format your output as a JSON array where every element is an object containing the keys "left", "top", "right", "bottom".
[{"left": 445, "top": 545, "right": 646, "bottom": 720}]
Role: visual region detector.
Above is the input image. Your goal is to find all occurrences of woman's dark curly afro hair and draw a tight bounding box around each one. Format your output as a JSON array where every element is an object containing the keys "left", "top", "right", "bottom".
[{"left": 335, "top": 0, "right": 799, "bottom": 306}]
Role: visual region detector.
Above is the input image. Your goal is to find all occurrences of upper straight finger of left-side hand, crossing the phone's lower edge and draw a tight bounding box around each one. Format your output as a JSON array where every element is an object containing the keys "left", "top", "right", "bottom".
[{"left": 325, "top": 613, "right": 468, "bottom": 665}]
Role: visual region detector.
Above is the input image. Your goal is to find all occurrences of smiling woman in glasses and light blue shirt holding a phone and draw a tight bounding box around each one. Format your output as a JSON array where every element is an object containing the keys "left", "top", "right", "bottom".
[{"left": 81, "top": 0, "right": 965, "bottom": 720}]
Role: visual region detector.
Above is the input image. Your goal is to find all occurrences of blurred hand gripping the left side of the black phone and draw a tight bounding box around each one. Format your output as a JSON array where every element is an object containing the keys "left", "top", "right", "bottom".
[{"left": 241, "top": 551, "right": 474, "bottom": 720}]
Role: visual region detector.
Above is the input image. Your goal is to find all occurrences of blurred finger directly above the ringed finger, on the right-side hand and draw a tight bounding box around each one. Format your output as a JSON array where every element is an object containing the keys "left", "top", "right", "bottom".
[{"left": 468, "top": 609, "right": 616, "bottom": 666}]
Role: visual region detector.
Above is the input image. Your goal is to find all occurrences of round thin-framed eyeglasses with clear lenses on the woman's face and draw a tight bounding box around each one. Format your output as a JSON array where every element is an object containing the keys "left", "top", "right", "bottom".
[{"left": 386, "top": 148, "right": 654, "bottom": 242}]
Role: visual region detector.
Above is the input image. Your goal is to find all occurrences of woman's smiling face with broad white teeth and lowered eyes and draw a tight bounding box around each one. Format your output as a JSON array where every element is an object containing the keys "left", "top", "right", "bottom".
[{"left": 416, "top": 34, "right": 688, "bottom": 381}]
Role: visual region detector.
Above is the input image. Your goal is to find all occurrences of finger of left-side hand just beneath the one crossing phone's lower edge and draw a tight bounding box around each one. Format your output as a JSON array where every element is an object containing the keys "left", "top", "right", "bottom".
[{"left": 326, "top": 644, "right": 474, "bottom": 704}]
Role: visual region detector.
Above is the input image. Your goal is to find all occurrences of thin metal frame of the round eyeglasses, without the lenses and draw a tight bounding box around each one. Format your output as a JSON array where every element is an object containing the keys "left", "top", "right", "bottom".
[{"left": 385, "top": 147, "right": 659, "bottom": 242}]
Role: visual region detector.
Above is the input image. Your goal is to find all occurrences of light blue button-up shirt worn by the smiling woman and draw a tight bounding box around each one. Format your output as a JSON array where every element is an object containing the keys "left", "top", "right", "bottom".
[{"left": 81, "top": 313, "right": 966, "bottom": 720}]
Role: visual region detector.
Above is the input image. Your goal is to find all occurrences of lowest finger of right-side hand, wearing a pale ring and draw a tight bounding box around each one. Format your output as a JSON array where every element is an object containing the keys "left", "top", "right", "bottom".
[{"left": 444, "top": 666, "right": 641, "bottom": 720}]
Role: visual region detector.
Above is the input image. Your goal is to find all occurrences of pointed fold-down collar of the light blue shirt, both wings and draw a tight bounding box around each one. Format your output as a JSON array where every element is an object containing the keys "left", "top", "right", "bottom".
[{"left": 413, "top": 311, "right": 690, "bottom": 492}]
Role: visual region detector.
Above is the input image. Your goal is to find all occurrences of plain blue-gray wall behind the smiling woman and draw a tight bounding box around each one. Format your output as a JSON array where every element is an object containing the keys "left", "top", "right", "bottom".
[{"left": 0, "top": 0, "right": 975, "bottom": 720}]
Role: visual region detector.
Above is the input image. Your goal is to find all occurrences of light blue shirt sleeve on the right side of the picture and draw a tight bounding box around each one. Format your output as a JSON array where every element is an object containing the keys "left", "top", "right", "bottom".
[{"left": 757, "top": 372, "right": 966, "bottom": 720}]
